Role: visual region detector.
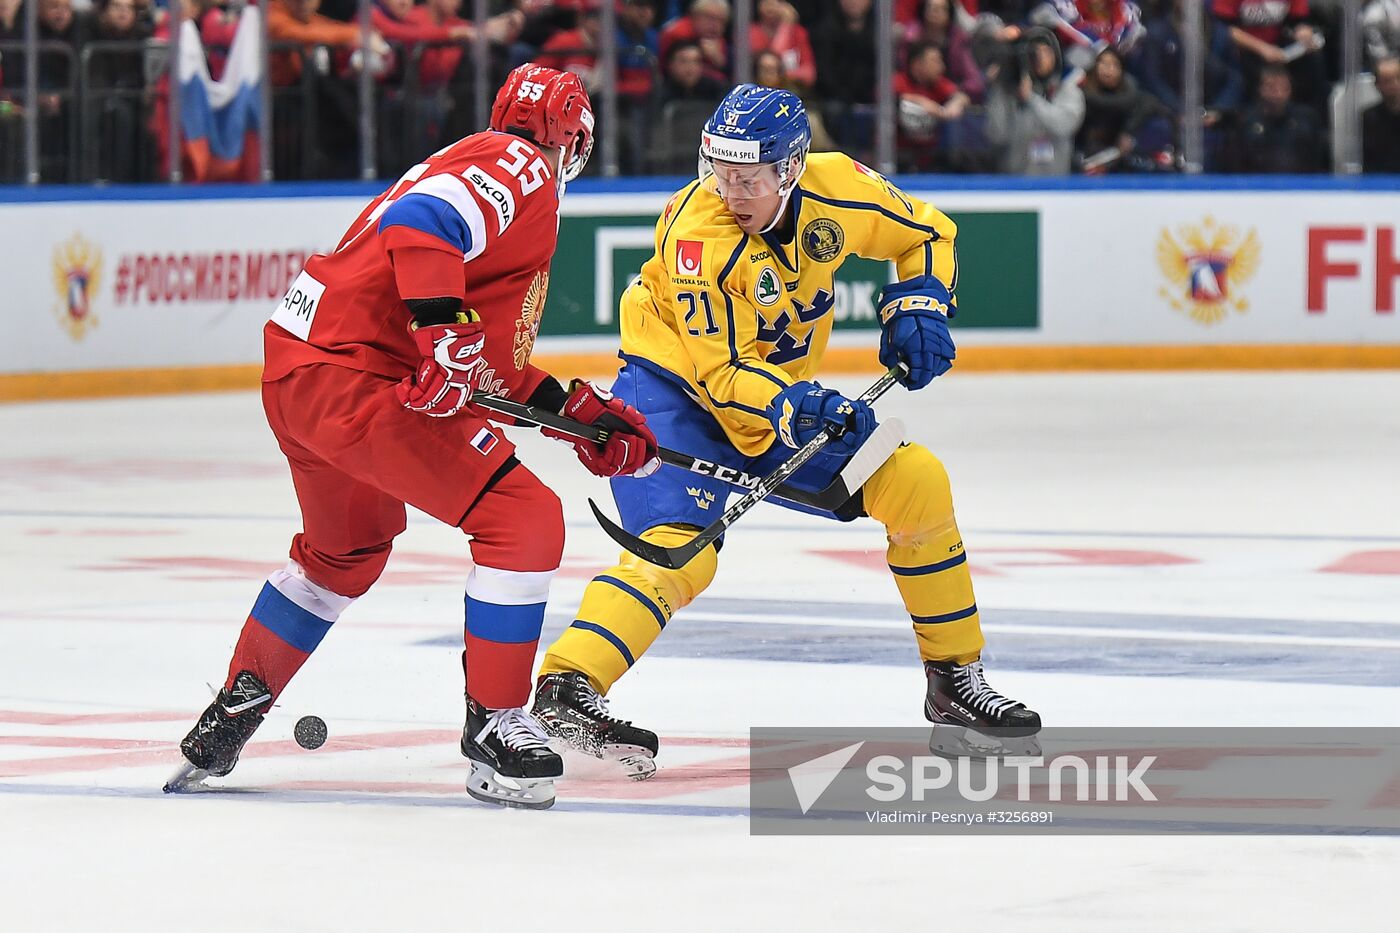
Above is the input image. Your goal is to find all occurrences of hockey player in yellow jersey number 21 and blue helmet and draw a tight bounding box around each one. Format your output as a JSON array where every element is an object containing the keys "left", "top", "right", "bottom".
[{"left": 533, "top": 84, "right": 1040, "bottom": 779}]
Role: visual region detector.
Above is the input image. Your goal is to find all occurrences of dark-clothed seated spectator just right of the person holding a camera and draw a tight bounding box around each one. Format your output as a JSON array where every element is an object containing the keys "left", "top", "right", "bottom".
[{"left": 1075, "top": 48, "right": 1166, "bottom": 174}]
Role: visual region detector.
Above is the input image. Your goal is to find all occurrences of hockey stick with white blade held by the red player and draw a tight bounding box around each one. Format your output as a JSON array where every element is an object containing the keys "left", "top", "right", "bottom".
[{"left": 472, "top": 395, "right": 904, "bottom": 511}]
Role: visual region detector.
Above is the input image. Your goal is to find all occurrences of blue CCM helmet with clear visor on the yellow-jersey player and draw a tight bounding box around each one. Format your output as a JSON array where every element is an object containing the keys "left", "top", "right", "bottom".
[{"left": 700, "top": 84, "right": 812, "bottom": 226}]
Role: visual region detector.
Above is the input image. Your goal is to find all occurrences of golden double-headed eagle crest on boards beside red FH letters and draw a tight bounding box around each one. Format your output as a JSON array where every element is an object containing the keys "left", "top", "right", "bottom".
[{"left": 1156, "top": 217, "right": 1260, "bottom": 326}]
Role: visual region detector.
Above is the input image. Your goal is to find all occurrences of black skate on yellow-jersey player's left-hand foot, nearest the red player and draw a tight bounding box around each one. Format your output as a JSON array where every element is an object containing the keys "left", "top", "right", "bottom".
[{"left": 535, "top": 671, "right": 658, "bottom": 780}]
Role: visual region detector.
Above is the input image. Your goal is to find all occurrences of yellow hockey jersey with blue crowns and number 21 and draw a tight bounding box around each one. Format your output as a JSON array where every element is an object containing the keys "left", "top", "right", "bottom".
[{"left": 620, "top": 153, "right": 958, "bottom": 455}]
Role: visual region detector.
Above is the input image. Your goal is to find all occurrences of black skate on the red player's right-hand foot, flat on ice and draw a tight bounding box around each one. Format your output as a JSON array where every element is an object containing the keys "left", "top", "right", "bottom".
[{"left": 462, "top": 696, "right": 564, "bottom": 810}]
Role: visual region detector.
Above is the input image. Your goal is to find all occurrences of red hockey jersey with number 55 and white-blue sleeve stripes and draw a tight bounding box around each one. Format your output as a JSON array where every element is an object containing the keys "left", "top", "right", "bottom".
[{"left": 263, "top": 132, "right": 559, "bottom": 398}]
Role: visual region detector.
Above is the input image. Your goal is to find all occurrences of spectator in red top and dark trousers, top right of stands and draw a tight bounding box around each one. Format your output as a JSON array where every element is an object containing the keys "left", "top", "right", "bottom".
[{"left": 1211, "top": 0, "right": 1329, "bottom": 113}]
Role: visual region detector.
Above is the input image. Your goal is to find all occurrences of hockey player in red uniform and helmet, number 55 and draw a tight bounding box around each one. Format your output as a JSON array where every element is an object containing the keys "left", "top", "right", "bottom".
[{"left": 167, "top": 64, "right": 658, "bottom": 807}]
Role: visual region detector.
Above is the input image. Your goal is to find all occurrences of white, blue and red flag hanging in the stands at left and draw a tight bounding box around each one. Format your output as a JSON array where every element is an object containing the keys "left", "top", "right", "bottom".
[{"left": 176, "top": 6, "right": 263, "bottom": 182}]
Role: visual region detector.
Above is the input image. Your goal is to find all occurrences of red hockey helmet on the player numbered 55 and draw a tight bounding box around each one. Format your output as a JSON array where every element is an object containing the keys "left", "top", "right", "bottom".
[{"left": 491, "top": 63, "right": 594, "bottom": 182}]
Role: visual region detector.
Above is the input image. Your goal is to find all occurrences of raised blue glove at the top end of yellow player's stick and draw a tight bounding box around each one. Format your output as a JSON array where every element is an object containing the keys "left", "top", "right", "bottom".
[{"left": 879, "top": 276, "right": 958, "bottom": 389}]
